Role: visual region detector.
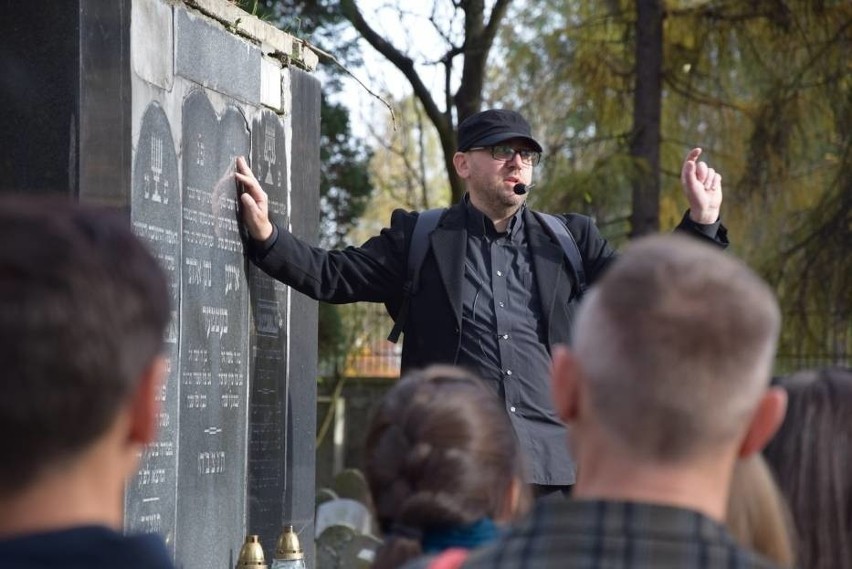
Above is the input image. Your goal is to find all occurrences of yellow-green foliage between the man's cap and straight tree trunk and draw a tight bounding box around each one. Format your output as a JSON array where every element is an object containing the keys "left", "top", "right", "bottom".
[{"left": 487, "top": 0, "right": 641, "bottom": 241}]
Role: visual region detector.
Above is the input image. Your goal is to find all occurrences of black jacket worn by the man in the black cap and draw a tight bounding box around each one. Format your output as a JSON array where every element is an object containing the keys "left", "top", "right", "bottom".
[{"left": 249, "top": 203, "right": 727, "bottom": 485}]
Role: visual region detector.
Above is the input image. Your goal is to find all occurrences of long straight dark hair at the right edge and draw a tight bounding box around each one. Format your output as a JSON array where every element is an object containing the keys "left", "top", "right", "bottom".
[{"left": 765, "top": 368, "right": 852, "bottom": 569}]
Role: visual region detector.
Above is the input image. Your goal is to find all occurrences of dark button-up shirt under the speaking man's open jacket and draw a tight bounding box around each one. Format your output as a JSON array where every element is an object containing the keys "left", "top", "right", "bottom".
[{"left": 458, "top": 201, "right": 574, "bottom": 484}]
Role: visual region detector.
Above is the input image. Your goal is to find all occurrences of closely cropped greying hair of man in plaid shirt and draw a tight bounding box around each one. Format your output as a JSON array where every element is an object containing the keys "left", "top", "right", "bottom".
[{"left": 573, "top": 235, "right": 783, "bottom": 463}]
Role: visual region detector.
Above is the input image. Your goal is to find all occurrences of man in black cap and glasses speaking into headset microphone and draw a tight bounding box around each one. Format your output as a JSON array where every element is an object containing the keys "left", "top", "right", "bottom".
[{"left": 236, "top": 109, "right": 727, "bottom": 494}]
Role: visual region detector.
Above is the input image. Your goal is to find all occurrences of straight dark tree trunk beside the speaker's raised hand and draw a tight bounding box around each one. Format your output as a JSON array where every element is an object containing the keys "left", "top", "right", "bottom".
[{"left": 630, "top": 0, "right": 663, "bottom": 238}]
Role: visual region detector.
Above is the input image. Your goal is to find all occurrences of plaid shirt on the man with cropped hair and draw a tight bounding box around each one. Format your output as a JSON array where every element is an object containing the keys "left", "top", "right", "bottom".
[{"left": 463, "top": 500, "right": 775, "bottom": 569}]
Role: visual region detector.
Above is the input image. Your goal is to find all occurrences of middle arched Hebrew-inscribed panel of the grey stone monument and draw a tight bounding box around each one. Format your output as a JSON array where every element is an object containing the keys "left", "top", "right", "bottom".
[{"left": 177, "top": 90, "right": 250, "bottom": 566}]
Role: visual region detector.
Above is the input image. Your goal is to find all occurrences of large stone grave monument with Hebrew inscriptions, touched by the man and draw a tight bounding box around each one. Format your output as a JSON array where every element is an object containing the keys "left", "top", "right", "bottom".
[{"left": 0, "top": 0, "right": 320, "bottom": 569}]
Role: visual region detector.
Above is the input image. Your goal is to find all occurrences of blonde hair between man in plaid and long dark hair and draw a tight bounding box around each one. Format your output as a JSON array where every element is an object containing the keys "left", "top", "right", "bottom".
[{"left": 725, "top": 453, "right": 795, "bottom": 567}]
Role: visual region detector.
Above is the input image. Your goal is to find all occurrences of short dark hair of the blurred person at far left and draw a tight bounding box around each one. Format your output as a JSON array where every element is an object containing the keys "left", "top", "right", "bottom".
[{"left": 0, "top": 195, "right": 171, "bottom": 493}]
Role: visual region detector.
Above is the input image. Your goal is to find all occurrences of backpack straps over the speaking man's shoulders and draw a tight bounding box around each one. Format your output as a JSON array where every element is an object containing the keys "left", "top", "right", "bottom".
[{"left": 388, "top": 208, "right": 586, "bottom": 344}]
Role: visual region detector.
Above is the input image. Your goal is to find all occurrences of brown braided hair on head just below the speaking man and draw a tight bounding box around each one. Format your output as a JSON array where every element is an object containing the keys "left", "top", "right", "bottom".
[{"left": 366, "top": 366, "right": 523, "bottom": 569}]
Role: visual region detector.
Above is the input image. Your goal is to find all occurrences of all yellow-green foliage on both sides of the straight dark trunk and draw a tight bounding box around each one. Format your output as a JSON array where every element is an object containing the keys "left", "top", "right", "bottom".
[{"left": 487, "top": 0, "right": 852, "bottom": 364}]
